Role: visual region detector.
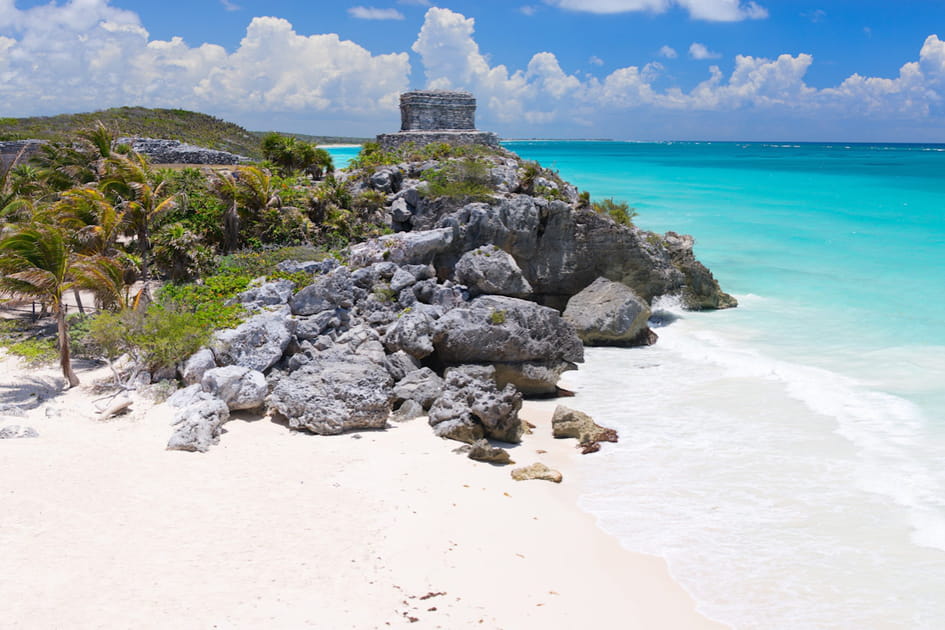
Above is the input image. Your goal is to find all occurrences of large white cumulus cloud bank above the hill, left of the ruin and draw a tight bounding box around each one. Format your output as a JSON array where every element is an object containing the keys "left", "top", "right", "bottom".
[{"left": 0, "top": 0, "right": 410, "bottom": 124}]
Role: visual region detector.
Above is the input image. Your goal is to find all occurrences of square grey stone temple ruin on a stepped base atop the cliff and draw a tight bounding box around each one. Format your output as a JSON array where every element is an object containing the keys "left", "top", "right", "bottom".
[{"left": 377, "top": 90, "right": 499, "bottom": 150}]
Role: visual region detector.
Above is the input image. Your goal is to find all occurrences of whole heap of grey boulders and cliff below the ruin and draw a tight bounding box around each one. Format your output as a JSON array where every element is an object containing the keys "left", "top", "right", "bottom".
[{"left": 168, "top": 148, "right": 734, "bottom": 464}]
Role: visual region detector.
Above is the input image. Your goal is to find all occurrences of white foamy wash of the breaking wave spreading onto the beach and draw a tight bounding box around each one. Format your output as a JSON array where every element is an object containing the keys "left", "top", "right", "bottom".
[{"left": 565, "top": 318, "right": 945, "bottom": 630}]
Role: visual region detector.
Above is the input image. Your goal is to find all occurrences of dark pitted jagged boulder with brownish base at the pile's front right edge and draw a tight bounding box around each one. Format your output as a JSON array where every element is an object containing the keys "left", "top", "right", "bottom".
[{"left": 428, "top": 365, "right": 524, "bottom": 444}]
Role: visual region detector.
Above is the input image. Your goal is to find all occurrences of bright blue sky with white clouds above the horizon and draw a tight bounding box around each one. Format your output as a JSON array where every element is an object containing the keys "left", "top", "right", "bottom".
[{"left": 0, "top": 0, "right": 945, "bottom": 142}]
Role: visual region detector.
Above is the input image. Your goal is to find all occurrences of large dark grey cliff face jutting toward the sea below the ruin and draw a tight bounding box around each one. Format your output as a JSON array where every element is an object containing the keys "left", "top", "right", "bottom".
[{"left": 426, "top": 194, "right": 736, "bottom": 309}]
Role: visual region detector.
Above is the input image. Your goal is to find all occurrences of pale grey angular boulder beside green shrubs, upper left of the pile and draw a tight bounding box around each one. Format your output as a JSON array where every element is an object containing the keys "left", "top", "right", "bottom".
[{"left": 210, "top": 307, "right": 296, "bottom": 372}]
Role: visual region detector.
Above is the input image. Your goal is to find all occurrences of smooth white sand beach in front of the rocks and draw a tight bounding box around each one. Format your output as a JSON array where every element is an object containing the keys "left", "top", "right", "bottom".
[{"left": 0, "top": 357, "right": 722, "bottom": 630}]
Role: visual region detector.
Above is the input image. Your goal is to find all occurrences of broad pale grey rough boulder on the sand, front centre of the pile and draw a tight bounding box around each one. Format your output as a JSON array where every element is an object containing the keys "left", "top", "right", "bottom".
[{"left": 268, "top": 347, "right": 394, "bottom": 435}]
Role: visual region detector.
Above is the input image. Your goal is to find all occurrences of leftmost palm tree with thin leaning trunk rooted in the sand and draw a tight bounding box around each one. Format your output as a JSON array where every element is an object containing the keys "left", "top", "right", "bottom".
[{"left": 0, "top": 223, "right": 79, "bottom": 387}]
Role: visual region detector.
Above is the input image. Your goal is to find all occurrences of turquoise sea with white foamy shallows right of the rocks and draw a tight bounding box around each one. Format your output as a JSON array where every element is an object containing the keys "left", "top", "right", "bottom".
[{"left": 339, "top": 141, "right": 945, "bottom": 630}]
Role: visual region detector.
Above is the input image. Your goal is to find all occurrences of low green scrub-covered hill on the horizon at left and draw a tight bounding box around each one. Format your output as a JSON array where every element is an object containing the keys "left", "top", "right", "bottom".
[{"left": 0, "top": 107, "right": 261, "bottom": 158}]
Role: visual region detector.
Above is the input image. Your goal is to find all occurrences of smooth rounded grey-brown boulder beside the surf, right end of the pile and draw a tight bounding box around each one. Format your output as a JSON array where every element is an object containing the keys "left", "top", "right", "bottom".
[{"left": 562, "top": 278, "right": 656, "bottom": 346}]
